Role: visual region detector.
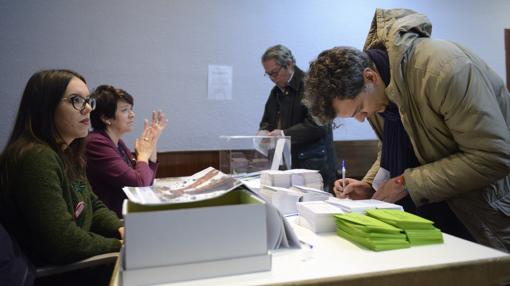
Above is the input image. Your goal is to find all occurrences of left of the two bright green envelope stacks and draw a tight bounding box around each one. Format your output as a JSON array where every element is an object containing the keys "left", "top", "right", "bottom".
[{"left": 335, "top": 213, "right": 409, "bottom": 251}]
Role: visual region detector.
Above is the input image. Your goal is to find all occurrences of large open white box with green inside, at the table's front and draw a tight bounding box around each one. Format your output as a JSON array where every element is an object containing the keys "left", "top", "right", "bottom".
[{"left": 122, "top": 190, "right": 270, "bottom": 274}]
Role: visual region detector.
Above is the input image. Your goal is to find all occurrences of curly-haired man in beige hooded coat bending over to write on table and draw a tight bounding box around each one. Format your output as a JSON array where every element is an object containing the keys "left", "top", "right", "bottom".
[{"left": 304, "top": 9, "right": 510, "bottom": 252}]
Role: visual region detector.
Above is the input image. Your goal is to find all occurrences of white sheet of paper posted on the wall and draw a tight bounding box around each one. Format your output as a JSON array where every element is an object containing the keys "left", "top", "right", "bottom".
[{"left": 207, "top": 65, "right": 232, "bottom": 100}]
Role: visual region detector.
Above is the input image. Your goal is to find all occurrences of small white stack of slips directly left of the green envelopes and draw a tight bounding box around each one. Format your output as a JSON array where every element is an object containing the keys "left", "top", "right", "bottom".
[{"left": 297, "top": 201, "right": 344, "bottom": 233}]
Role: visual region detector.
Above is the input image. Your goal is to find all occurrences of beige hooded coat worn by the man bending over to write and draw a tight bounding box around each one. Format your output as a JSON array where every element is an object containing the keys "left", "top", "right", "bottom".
[{"left": 363, "top": 9, "right": 510, "bottom": 252}]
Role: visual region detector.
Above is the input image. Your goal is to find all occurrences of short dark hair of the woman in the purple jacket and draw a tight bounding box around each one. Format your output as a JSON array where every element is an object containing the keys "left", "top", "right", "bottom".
[{"left": 90, "top": 85, "right": 134, "bottom": 130}]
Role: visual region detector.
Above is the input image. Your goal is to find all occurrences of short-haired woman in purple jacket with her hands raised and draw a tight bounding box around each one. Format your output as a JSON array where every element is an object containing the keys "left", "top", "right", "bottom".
[{"left": 86, "top": 85, "right": 167, "bottom": 217}]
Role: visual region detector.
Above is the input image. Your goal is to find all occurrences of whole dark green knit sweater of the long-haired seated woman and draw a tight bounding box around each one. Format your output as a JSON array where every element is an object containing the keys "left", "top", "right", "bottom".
[{"left": 0, "top": 145, "right": 122, "bottom": 265}]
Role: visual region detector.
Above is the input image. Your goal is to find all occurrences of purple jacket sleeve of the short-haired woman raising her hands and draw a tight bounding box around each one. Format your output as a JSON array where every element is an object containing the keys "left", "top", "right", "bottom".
[{"left": 86, "top": 133, "right": 157, "bottom": 188}]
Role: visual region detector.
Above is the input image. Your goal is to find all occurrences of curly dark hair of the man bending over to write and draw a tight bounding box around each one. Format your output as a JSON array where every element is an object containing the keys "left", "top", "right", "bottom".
[{"left": 303, "top": 47, "right": 374, "bottom": 124}]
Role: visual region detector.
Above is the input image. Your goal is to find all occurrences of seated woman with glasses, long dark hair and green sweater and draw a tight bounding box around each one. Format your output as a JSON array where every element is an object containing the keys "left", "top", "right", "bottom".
[{"left": 0, "top": 70, "right": 123, "bottom": 284}]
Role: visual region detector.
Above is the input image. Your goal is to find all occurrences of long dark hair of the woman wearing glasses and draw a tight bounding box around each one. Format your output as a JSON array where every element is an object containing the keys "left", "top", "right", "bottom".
[{"left": 0, "top": 69, "right": 86, "bottom": 179}]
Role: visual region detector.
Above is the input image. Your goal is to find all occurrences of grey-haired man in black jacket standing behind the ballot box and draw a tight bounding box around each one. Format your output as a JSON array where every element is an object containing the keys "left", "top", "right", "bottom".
[{"left": 258, "top": 45, "right": 337, "bottom": 191}]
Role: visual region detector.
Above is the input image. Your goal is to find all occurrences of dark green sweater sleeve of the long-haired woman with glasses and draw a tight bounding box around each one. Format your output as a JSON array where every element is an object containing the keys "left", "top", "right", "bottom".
[{"left": 15, "top": 147, "right": 121, "bottom": 264}]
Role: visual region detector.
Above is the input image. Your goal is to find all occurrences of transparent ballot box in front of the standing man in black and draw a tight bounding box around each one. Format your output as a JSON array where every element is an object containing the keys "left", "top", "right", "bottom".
[{"left": 220, "top": 136, "right": 292, "bottom": 175}]
